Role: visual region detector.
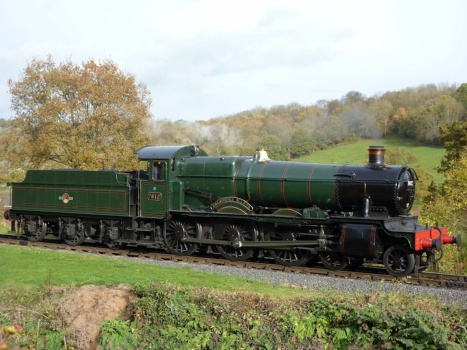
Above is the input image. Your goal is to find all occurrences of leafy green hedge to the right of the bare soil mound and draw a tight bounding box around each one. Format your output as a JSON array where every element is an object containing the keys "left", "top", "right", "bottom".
[{"left": 130, "top": 285, "right": 467, "bottom": 349}]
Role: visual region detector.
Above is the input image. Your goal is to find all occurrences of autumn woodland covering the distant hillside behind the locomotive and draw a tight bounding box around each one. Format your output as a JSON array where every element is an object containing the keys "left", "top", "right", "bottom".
[{"left": 154, "top": 83, "right": 467, "bottom": 160}]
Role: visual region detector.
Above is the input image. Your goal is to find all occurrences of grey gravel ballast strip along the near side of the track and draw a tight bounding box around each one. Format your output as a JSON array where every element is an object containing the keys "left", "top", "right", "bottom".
[{"left": 110, "top": 253, "right": 467, "bottom": 310}]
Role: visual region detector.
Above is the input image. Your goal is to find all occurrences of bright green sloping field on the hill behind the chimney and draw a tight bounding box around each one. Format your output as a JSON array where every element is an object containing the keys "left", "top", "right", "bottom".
[{"left": 294, "top": 138, "right": 445, "bottom": 183}]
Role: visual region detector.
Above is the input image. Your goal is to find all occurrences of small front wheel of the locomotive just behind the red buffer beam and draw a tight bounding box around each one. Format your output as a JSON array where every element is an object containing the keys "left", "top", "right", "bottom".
[{"left": 383, "top": 245, "right": 415, "bottom": 277}]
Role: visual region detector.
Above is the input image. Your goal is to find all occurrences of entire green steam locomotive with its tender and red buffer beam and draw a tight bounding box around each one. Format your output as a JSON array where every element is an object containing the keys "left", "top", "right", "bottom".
[{"left": 4, "top": 146, "right": 460, "bottom": 276}]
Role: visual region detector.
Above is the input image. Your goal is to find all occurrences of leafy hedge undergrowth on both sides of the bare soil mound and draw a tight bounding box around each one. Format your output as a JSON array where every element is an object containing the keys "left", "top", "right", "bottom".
[{"left": 0, "top": 283, "right": 467, "bottom": 350}]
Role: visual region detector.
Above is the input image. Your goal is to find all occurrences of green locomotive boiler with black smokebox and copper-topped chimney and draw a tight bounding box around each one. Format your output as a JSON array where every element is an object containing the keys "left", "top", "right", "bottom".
[{"left": 179, "top": 146, "right": 416, "bottom": 216}]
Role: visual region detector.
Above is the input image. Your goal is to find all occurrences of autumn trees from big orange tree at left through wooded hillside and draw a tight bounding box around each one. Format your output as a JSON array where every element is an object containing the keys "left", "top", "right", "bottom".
[{"left": 0, "top": 56, "right": 467, "bottom": 172}]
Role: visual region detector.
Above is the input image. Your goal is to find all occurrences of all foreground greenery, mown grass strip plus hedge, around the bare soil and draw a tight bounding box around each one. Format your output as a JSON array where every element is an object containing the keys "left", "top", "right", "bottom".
[{"left": 0, "top": 245, "right": 467, "bottom": 349}]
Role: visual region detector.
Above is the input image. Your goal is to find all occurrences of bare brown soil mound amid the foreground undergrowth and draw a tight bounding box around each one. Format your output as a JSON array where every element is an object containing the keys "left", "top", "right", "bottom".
[{"left": 57, "top": 284, "right": 136, "bottom": 350}]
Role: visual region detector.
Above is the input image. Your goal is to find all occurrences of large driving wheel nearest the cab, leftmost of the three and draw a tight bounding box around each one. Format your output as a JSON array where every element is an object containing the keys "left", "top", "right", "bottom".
[{"left": 164, "top": 219, "right": 198, "bottom": 255}]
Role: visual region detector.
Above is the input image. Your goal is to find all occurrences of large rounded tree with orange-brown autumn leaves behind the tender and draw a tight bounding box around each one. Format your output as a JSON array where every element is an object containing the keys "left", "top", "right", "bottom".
[{"left": 1, "top": 56, "right": 151, "bottom": 169}]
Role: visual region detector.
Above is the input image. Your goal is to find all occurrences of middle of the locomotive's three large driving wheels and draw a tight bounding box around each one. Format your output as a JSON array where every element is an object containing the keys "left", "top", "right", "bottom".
[{"left": 217, "top": 222, "right": 257, "bottom": 261}]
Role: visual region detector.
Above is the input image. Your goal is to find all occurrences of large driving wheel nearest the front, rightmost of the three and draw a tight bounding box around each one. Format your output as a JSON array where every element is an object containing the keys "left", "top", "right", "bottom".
[{"left": 265, "top": 228, "right": 312, "bottom": 266}]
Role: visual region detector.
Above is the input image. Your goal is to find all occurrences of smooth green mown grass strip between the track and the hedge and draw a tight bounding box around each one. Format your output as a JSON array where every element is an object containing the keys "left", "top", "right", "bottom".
[{"left": 0, "top": 244, "right": 312, "bottom": 297}]
